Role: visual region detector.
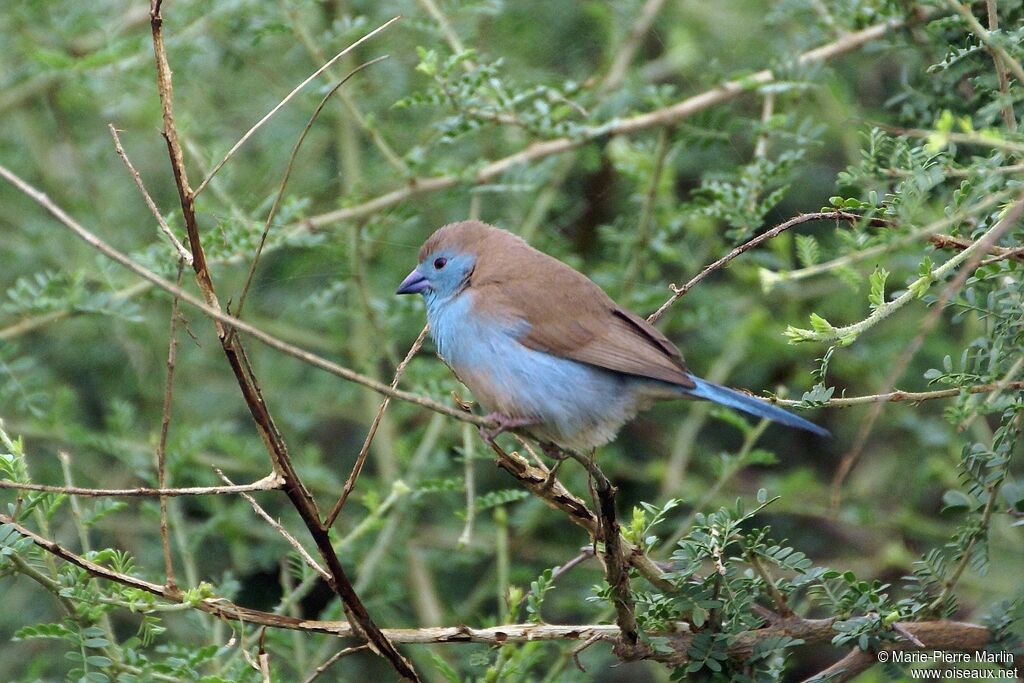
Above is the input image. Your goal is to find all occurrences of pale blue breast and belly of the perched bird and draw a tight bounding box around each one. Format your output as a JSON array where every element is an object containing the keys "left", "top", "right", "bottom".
[{"left": 427, "top": 292, "right": 650, "bottom": 451}]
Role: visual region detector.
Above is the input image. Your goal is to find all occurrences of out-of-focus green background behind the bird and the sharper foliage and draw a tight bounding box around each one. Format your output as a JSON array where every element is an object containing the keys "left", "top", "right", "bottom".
[{"left": 0, "top": 0, "right": 1024, "bottom": 681}]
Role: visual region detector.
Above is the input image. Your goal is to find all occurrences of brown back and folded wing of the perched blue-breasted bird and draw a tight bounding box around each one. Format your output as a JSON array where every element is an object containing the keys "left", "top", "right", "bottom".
[{"left": 471, "top": 250, "right": 694, "bottom": 387}]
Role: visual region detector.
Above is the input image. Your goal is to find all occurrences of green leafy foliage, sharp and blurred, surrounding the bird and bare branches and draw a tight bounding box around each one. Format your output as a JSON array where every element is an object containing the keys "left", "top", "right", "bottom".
[{"left": 0, "top": 0, "right": 1024, "bottom": 683}]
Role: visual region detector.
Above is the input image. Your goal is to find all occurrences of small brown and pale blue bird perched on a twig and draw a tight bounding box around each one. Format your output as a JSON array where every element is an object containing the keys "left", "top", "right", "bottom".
[{"left": 396, "top": 220, "right": 828, "bottom": 454}]
